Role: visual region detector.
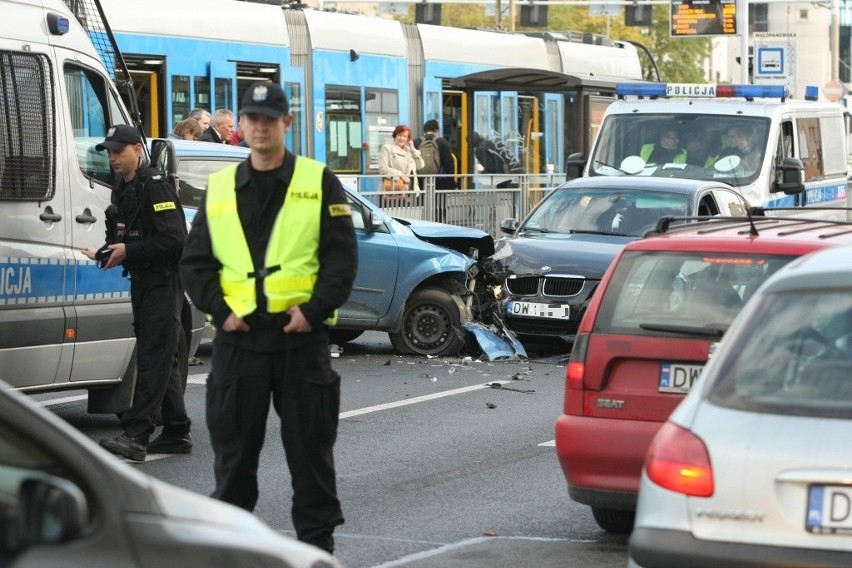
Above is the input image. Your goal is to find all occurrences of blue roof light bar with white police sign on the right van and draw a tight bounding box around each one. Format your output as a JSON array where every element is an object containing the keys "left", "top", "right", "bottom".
[{"left": 615, "top": 83, "right": 790, "bottom": 100}]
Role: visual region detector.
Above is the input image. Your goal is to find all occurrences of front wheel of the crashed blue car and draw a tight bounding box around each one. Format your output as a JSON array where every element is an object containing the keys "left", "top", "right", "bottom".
[{"left": 388, "top": 288, "right": 464, "bottom": 355}]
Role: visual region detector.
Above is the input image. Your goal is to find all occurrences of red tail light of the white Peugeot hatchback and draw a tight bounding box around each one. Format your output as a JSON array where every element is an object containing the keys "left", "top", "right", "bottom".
[{"left": 645, "top": 422, "right": 713, "bottom": 497}]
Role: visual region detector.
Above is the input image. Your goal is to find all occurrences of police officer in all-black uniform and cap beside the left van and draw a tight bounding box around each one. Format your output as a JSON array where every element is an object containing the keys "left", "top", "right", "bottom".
[{"left": 82, "top": 124, "right": 192, "bottom": 461}]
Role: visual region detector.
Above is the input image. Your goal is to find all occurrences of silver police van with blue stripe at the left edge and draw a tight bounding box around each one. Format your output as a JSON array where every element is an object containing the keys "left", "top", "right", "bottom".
[{"left": 0, "top": 0, "right": 200, "bottom": 413}]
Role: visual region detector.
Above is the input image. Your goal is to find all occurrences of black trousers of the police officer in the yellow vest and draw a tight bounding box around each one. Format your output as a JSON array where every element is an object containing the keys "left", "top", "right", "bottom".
[{"left": 207, "top": 340, "right": 343, "bottom": 542}]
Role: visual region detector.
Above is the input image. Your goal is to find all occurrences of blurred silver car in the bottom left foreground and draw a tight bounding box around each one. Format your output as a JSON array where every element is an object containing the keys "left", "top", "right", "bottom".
[{"left": 0, "top": 381, "right": 342, "bottom": 568}]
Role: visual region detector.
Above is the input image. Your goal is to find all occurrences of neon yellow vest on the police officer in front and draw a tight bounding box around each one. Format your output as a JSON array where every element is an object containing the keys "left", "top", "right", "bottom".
[{"left": 206, "top": 156, "right": 326, "bottom": 319}]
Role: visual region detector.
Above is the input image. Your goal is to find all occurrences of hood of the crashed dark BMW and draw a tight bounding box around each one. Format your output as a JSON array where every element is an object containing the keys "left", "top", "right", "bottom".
[{"left": 485, "top": 235, "right": 635, "bottom": 280}]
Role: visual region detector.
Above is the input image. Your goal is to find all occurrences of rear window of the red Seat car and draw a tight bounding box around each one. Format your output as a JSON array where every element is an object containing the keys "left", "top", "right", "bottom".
[{"left": 594, "top": 251, "right": 794, "bottom": 337}]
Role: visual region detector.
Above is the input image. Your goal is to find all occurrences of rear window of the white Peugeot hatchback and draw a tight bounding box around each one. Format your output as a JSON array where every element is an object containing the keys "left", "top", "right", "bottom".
[{"left": 708, "top": 290, "right": 852, "bottom": 418}]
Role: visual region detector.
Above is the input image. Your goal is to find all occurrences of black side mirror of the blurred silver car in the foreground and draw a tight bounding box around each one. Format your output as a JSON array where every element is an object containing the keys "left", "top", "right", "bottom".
[{"left": 6, "top": 476, "right": 89, "bottom": 552}]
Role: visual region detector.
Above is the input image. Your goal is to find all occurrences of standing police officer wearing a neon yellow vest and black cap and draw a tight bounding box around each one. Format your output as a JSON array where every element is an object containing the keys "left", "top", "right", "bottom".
[{"left": 180, "top": 83, "right": 358, "bottom": 552}]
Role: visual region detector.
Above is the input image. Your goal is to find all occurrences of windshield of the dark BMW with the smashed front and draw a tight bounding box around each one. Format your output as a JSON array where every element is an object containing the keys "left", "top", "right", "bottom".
[{"left": 519, "top": 188, "right": 689, "bottom": 236}]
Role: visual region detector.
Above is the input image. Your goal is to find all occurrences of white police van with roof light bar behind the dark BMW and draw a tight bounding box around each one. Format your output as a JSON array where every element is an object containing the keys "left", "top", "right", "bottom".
[{"left": 569, "top": 83, "right": 852, "bottom": 215}]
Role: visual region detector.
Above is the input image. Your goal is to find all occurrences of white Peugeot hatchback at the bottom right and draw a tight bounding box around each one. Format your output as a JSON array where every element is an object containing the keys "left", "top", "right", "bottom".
[{"left": 630, "top": 246, "right": 852, "bottom": 568}]
